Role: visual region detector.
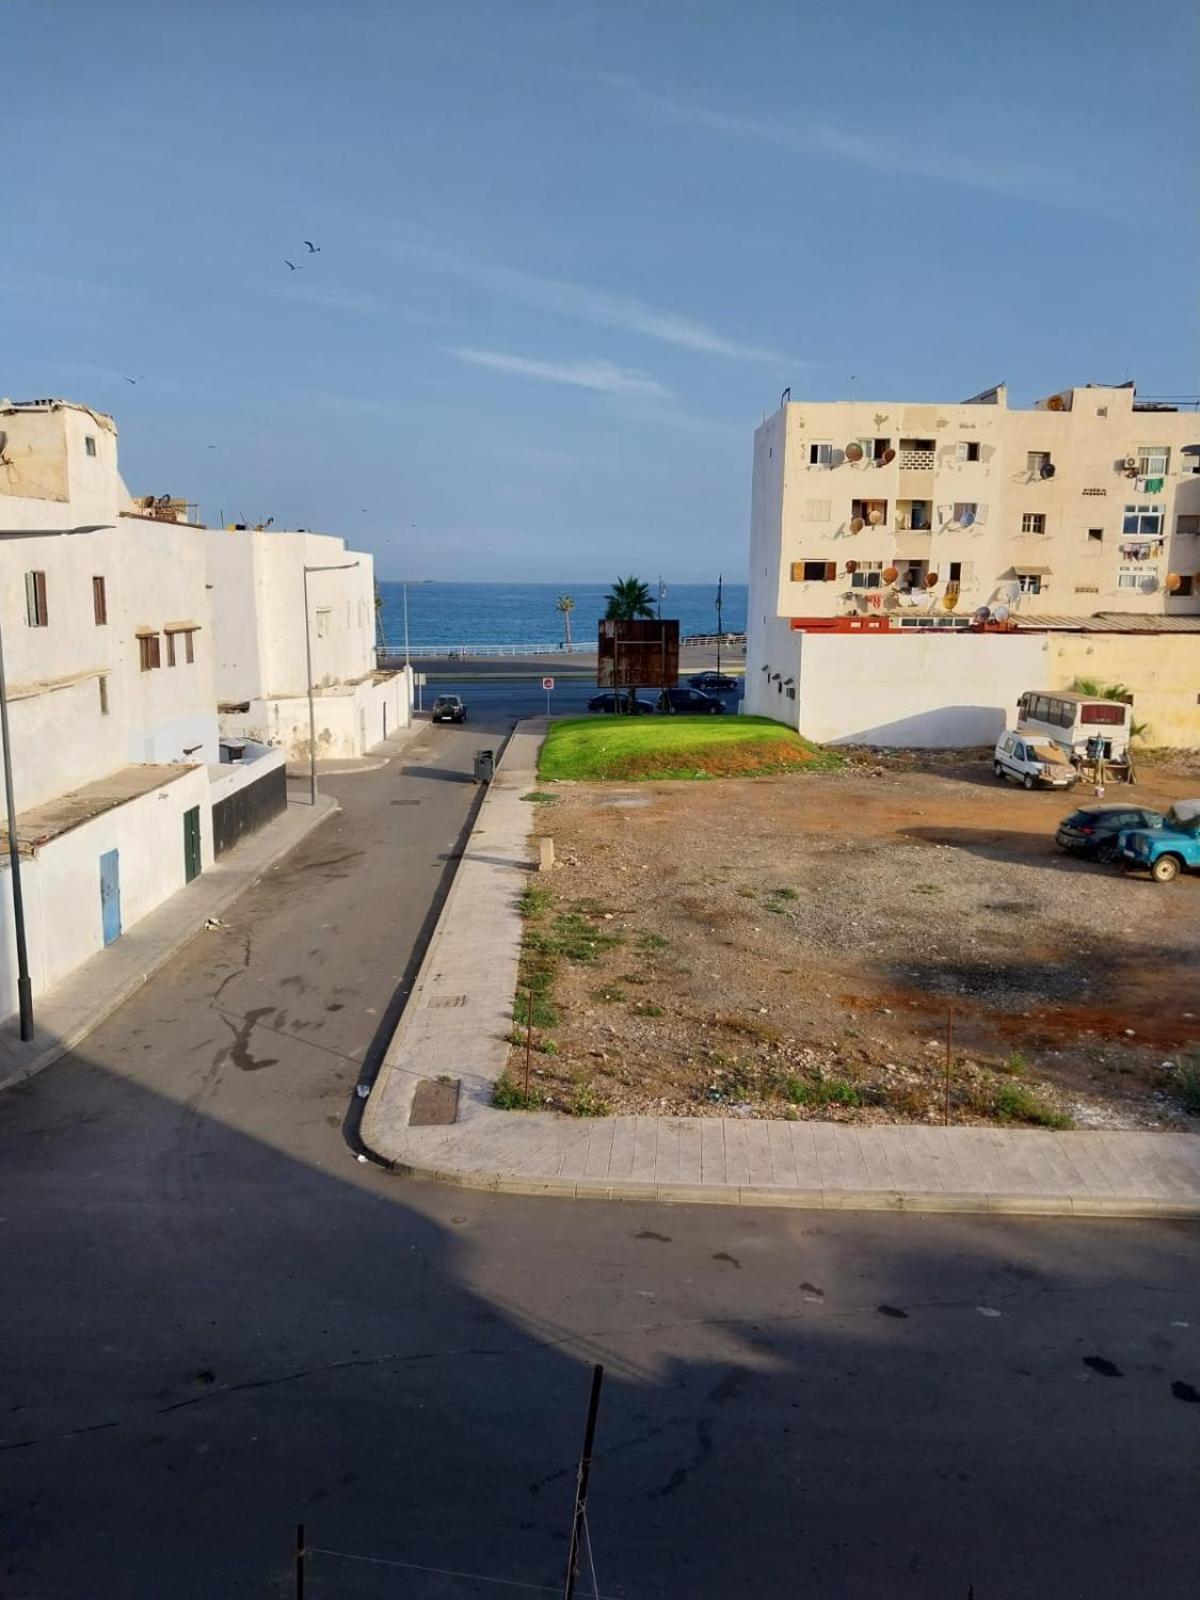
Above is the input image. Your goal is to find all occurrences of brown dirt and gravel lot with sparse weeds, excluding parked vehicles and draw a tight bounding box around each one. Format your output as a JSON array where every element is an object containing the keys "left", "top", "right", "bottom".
[{"left": 514, "top": 757, "right": 1200, "bottom": 1131}]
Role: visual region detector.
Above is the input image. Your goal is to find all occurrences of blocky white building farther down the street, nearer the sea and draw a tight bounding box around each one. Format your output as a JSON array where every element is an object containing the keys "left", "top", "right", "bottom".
[{"left": 206, "top": 528, "right": 411, "bottom": 762}]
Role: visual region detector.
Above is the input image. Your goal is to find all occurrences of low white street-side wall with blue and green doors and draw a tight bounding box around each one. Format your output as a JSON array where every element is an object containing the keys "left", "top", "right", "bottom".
[{"left": 0, "top": 766, "right": 213, "bottom": 1016}]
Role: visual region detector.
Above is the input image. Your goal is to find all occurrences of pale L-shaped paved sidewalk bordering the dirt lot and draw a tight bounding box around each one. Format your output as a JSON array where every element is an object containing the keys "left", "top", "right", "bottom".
[{"left": 362, "top": 718, "right": 1200, "bottom": 1216}]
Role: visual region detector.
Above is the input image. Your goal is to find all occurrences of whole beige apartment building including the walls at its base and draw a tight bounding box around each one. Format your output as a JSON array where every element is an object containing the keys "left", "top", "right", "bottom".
[{"left": 746, "top": 384, "right": 1200, "bottom": 744}]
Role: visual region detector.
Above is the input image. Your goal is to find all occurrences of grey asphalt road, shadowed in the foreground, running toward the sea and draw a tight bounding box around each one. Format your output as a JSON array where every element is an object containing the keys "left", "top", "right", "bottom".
[{"left": 0, "top": 709, "right": 1200, "bottom": 1600}]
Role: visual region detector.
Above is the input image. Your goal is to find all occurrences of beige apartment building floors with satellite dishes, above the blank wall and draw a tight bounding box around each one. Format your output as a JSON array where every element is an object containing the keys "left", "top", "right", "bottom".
[{"left": 750, "top": 384, "right": 1200, "bottom": 634}]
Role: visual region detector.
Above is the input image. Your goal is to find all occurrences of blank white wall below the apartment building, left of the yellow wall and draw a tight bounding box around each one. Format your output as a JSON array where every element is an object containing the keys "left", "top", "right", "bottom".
[{"left": 794, "top": 632, "right": 1048, "bottom": 749}]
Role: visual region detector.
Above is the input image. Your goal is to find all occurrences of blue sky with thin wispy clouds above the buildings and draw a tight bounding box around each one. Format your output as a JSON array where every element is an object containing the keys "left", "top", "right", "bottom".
[{"left": 0, "top": 0, "right": 1200, "bottom": 581}]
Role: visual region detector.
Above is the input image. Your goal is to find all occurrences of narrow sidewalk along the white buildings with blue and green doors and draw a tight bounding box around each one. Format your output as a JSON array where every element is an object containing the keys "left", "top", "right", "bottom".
[{"left": 0, "top": 795, "right": 339, "bottom": 1090}]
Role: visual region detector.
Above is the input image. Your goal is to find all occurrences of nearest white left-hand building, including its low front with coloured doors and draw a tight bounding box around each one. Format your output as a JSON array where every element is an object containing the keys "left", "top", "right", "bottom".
[{"left": 0, "top": 400, "right": 225, "bottom": 1016}]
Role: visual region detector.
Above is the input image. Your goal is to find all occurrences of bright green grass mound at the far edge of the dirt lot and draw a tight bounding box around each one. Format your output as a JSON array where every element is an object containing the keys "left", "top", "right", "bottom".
[{"left": 538, "top": 715, "right": 842, "bottom": 779}]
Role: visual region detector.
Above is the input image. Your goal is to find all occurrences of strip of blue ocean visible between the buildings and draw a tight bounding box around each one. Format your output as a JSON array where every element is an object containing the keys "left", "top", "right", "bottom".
[{"left": 379, "top": 579, "right": 746, "bottom": 653}]
